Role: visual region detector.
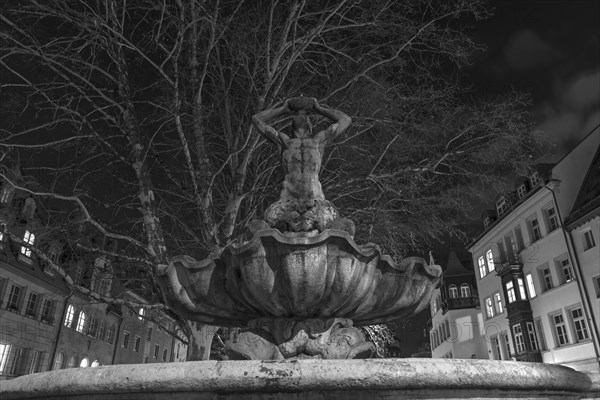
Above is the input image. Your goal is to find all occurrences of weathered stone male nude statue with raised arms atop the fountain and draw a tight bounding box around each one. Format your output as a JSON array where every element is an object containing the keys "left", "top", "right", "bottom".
[{"left": 252, "top": 97, "right": 354, "bottom": 235}]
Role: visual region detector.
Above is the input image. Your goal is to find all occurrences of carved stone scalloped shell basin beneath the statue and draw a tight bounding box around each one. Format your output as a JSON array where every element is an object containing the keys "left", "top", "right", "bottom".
[{"left": 157, "top": 229, "right": 442, "bottom": 326}]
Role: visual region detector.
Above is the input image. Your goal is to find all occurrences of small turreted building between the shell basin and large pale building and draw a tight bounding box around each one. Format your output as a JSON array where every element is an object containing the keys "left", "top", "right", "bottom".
[{"left": 429, "top": 251, "right": 488, "bottom": 359}]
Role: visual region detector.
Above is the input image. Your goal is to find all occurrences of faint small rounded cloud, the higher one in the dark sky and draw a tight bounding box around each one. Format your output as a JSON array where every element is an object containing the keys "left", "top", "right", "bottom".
[{"left": 504, "top": 29, "right": 559, "bottom": 70}]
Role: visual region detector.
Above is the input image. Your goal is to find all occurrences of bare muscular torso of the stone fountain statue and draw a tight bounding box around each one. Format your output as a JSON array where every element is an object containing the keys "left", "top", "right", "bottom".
[{"left": 281, "top": 138, "right": 325, "bottom": 200}]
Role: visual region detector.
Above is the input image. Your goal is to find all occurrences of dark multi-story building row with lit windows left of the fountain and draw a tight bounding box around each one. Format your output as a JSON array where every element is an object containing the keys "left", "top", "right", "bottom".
[{"left": 0, "top": 177, "right": 187, "bottom": 379}]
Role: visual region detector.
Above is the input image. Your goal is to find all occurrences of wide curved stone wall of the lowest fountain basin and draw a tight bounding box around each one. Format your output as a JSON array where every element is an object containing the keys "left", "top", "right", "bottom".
[{"left": 0, "top": 358, "right": 600, "bottom": 400}]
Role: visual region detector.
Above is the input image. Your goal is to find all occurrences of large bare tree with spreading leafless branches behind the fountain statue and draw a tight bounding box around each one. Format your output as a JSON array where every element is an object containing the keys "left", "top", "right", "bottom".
[{"left": 0, "top": 0, "right": 534, "bottom": 358}]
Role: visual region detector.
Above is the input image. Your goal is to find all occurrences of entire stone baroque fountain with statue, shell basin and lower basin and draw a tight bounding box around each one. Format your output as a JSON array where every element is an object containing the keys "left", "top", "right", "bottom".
[{"left": 0, "top": 97, "right": 600, "bottom": 400}]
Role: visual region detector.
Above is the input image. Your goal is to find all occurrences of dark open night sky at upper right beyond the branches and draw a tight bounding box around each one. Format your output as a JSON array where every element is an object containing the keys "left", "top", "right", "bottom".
[{"left": 467, "top": 0, "right": 600, "bottom": 162}]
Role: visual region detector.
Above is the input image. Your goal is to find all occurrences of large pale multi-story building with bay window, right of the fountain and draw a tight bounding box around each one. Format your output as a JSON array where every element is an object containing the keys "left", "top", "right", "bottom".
[{"left": 470, "top": 129, "right": 600, "bottom": 370}]
